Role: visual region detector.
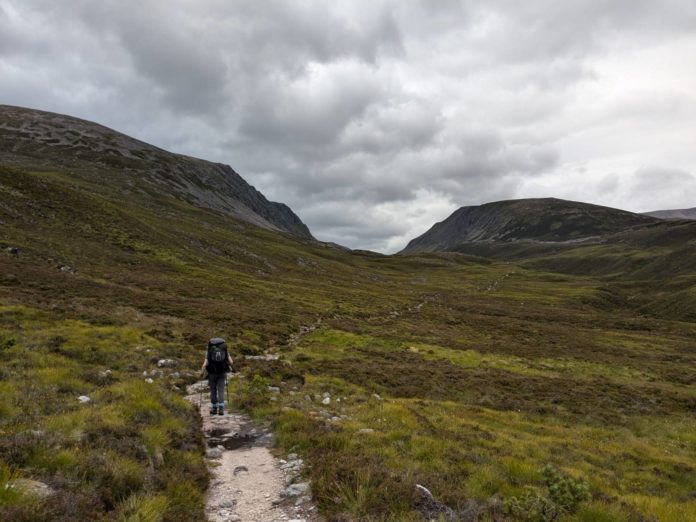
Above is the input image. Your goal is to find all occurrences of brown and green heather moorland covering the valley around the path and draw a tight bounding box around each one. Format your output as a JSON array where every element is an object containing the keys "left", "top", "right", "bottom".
[{"left": 0, "top": 107, "right": 696, "bottom": 522}]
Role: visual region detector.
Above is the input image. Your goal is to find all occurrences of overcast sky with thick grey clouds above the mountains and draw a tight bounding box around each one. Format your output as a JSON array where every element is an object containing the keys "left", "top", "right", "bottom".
[{"left": 0, "top": 0, "right": 696, "bottom": 252}]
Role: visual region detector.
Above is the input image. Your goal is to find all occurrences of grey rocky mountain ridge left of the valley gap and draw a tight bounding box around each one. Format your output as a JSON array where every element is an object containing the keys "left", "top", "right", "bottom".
[{"left": 0, "top": 105, "right": 313, "bottom": 239}]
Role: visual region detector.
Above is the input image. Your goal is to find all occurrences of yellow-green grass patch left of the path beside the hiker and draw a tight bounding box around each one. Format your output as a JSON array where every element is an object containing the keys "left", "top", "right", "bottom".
[{"left": 0, "top": 306, "right": 208, "bottom": 521}]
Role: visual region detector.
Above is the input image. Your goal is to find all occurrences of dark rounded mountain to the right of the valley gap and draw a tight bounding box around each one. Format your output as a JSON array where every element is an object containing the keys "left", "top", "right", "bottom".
[{"left": 402, "top": 198, "right": 659, "bottom": 253}]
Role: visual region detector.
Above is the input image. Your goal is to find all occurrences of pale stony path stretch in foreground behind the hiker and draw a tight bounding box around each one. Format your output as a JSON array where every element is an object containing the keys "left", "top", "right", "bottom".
[{"left": 187, "top": 382, "right": 322, "bottom": 522}]
